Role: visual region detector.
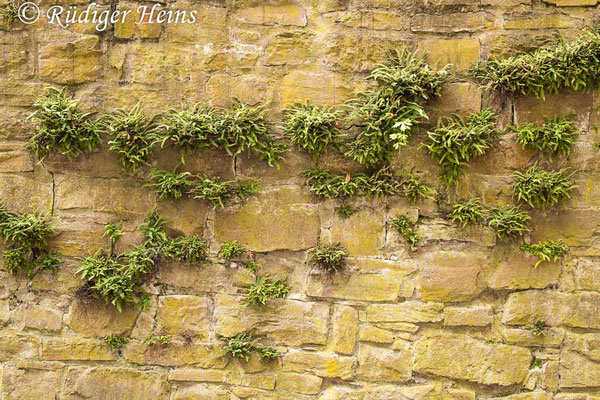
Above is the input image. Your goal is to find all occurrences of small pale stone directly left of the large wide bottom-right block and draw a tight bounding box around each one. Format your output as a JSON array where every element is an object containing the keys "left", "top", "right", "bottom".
[{"left": 357, "top": 344, "right": 412, "bottom": 382}]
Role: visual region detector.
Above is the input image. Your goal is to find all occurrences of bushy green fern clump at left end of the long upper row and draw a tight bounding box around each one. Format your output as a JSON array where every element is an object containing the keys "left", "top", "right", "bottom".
[{"left": 27, "top": 87, "right": 102, "bottom": 160}]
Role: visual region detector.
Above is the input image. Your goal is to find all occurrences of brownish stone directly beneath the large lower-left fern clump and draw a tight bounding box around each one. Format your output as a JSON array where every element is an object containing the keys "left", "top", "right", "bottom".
[{"left": 65, "top": 300, "right": 139, "bottom": 337}]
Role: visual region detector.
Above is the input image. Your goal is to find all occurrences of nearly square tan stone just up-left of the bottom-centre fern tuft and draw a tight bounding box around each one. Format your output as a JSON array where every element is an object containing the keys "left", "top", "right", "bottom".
[{"left": 156, "top": 296, "right": 211, "bottom": 339}]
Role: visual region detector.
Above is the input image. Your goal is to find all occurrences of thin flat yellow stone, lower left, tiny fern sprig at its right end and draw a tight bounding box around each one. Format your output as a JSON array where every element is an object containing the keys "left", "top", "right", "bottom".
[{"left": 42, "top": 338, "right": 116, "bottom": 361}]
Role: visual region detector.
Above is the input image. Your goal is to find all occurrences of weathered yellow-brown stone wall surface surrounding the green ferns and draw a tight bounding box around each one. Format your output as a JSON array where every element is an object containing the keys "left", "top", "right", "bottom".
[{"left": 0, "top": 0, "right": 600, "bottom": 400}]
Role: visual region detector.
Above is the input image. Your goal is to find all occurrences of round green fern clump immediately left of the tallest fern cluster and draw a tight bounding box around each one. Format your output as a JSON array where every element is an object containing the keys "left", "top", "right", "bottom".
[{"left": 283, "top": 104, "right": 343, "bottom": 161}]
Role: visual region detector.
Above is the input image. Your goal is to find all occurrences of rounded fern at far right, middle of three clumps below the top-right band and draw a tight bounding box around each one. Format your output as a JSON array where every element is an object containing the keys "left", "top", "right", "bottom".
[{"left": 513, "top": 164, "right": 577, "bottom": 209}]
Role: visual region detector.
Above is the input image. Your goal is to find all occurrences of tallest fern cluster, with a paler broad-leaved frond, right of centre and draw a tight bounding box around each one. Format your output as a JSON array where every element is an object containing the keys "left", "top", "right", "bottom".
[{"left": 345, "top": 51, "right": 448, "bottom": 166}]
